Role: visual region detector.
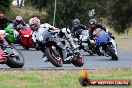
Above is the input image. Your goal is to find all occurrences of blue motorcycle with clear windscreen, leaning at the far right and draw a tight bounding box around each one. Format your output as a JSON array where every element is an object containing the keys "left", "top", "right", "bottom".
[{"left": 93, "top": 28, "right": 118, "bottom": 61}]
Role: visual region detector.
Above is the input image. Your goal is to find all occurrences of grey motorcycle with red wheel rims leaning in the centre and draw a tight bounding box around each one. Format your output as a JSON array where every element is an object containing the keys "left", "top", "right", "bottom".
[{"left": 33, "top": 29, "right": 84, "bottom": 67}]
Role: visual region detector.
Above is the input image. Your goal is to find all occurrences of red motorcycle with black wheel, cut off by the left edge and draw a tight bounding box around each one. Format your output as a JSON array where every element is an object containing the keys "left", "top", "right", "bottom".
[{"left": 0, "top": 44, "right": 24, "bottom": 68}]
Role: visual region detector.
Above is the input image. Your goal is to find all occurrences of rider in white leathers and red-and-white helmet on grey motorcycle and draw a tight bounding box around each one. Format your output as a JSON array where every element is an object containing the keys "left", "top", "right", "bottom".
[{"left": 29, "top": 17, "right": 78, "bottom": 61}]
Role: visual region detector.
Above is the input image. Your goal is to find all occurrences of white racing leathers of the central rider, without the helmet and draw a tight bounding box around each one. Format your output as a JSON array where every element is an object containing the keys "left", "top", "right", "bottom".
[{"left": 32, "top": 23, "right": 77, "bottom": 61}]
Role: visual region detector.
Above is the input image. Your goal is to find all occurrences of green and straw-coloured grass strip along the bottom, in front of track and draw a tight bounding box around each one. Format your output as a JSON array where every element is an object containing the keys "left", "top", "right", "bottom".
[{"left": 0, "top": 68, "right": 132, "bottom": 88}]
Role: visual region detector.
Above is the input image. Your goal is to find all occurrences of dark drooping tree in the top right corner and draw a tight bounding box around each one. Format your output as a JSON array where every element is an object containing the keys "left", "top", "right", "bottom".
[{"left": 107, "top": 0, "right": 132, "bottom": 34}]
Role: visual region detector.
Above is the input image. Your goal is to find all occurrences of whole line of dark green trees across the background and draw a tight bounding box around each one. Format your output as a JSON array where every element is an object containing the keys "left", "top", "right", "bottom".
[{"left": 0, "top": 0, "right": 132, "bottom": 34}]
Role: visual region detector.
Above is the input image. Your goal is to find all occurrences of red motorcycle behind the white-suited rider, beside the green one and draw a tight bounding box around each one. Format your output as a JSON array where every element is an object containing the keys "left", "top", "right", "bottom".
[{"left": 18, "top": 24, "right": 34, "bottom": 49}]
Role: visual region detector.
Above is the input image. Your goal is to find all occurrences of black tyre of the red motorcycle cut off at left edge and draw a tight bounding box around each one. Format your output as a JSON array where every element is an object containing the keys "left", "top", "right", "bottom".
[{"left": 6, "top": 47, "right": 24, "bottom": 68}]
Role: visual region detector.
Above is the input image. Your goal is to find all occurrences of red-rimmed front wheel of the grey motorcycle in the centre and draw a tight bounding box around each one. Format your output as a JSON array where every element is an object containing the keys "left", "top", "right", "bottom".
[{"left": 45, "top": 46, "right": 63, "bottom": 67}]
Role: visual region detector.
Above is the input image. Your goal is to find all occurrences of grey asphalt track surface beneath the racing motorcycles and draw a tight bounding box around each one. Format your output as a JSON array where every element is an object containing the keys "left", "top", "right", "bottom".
[{"left": 0, "top": 45, "right": 132, "bottom": 69}]
